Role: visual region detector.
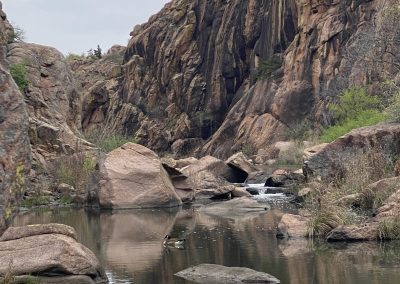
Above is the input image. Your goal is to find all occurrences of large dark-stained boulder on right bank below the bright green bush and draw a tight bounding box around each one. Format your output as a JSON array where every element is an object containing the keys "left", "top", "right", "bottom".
[{"left": 303, "top": 123, "right": 400, "bottom": 181}]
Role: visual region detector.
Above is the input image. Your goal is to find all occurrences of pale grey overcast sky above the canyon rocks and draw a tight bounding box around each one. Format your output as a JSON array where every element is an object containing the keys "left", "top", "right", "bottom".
[{"left": 0, "top": 0, "right": 169, "bottom": 54}]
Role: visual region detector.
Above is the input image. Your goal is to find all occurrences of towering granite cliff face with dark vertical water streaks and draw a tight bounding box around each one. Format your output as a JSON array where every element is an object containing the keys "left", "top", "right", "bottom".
[{"left": 80, "top": 0, "right": 398, "bottom": 159}]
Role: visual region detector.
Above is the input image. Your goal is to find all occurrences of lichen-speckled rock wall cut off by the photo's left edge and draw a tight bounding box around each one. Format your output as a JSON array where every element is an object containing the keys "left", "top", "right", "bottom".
[{"left": 0, "top": 2, "right": 31, "bottom": 235}]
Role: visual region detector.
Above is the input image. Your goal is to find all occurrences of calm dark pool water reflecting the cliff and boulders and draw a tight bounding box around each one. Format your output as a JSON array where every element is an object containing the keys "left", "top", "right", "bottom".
[{"left": 10, "top": 208, "right": 400, "bottom": 284}]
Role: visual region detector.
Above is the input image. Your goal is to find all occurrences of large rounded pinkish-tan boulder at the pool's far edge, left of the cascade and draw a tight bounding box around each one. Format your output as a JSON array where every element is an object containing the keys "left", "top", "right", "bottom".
[{"left": 99, "top": 143, "right": 182, "bottom": 209}]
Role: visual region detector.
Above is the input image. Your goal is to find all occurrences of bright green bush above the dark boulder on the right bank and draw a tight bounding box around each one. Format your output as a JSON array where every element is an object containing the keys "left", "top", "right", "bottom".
[{"left": 320, "top": 110, "right": 387, "bottom": 142}]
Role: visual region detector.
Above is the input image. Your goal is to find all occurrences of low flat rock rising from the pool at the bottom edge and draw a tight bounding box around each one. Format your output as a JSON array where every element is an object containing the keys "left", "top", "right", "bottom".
[{"left": 175, "top": 264, "right": 281, "bottom": 284}]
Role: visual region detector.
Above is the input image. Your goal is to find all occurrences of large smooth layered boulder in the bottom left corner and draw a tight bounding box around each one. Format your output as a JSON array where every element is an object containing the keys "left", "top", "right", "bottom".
[{"left": 0, "top": 224, "right": 107, "bottom": 283}]
